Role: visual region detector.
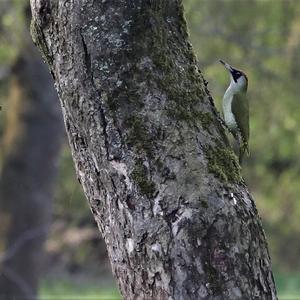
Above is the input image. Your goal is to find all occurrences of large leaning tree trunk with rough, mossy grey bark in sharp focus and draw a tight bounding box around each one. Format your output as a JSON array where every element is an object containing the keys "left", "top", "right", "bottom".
[{"left": 31, "top": 0, "right": 276, "bottom": 299}]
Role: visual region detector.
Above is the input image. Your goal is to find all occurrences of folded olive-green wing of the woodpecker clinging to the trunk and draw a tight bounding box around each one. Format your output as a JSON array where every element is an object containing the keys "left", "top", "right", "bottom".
[{"left": 231, "top": 92, "right": 249, "bottom": 152}]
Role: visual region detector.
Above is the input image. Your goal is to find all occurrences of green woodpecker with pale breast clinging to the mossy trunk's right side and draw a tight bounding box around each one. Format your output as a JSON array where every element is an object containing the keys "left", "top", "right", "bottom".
[{"left": 220, "top": 60, "right": 249, "bottom": 163}]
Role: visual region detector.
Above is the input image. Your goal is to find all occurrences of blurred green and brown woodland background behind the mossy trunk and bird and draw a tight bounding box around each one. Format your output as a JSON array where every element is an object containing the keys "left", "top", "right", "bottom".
[{"left": 0, "top": 0, "right": 300, "bottom": 300}]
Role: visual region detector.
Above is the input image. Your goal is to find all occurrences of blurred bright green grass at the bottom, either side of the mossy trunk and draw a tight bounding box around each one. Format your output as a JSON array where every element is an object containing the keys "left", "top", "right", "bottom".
[{"left": 40, "top": 273, "right": 300, "bottom": 300}]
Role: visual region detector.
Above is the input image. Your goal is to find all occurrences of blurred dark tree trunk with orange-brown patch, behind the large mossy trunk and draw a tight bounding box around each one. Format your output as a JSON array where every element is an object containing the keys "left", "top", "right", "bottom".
[{"left": 0, "top": 7, "right": 63, "bottom": 300}]
